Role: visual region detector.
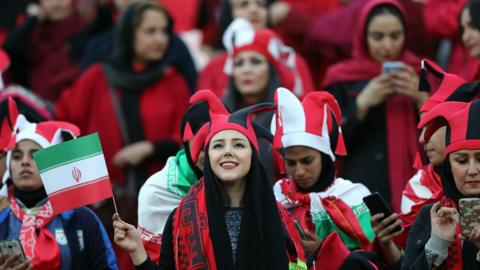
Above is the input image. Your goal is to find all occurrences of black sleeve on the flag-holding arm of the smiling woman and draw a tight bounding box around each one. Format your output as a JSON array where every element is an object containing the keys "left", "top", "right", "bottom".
[{"left": 135, "top": 209, "right": 176, "bottom": 270}]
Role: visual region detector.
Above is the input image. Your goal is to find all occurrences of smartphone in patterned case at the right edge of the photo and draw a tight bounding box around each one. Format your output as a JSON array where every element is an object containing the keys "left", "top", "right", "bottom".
[{"left": 459, "top": 198, "right": 480, "bottom": 237}]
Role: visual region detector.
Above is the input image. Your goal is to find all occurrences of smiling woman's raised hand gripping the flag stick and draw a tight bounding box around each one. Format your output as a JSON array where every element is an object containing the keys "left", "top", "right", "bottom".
[{"left": 112, "top": 214, "right": 148, "bottom": 265}]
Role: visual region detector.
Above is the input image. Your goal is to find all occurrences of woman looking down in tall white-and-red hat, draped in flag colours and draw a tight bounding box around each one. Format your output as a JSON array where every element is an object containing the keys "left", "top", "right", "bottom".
[{"left": 274, "top": 88, "right": 374, "bottom": 255}]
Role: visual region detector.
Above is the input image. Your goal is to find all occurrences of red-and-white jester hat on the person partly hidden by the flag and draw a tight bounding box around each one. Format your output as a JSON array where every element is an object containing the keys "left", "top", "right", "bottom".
[{"left": 1, "top": 114, "right": 80, "bottom": 195}]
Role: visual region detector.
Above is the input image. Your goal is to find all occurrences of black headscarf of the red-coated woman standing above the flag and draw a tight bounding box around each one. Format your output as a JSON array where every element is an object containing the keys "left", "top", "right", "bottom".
[{"left": 112, "top": 0, "right": 173, "bottom": 70}]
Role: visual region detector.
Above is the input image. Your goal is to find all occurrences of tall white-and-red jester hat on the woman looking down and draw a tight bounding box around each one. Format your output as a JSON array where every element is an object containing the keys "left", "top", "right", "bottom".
[{"left": 272, "top": 87, "right": 347, "bottom": 161}]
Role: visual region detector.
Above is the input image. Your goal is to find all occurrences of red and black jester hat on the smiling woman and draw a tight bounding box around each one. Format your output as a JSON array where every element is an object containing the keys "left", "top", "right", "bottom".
[{"left": 190, "top": 90, "right": 275, "bottom": 162}]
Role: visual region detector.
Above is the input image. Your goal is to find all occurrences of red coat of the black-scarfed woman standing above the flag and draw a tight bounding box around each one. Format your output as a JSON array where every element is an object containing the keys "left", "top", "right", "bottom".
[{"left": 56, "top": 64, "right": 190, "bottom": 186}]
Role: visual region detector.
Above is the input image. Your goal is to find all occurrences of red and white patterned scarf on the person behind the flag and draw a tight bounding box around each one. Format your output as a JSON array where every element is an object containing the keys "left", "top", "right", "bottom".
[{"left": 10, "top": 193, "right": 61, "bottom": 269}]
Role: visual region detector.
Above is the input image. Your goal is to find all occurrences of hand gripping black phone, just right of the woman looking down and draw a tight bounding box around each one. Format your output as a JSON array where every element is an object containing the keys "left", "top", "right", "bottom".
[{"left": 370, "top": 213, "right": 403, "bottom": 264}]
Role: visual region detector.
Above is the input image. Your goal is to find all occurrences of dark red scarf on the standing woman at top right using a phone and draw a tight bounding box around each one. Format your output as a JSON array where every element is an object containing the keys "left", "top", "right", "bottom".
[{"left": 323, "top": 0, "right": 420, "bottom": 212}]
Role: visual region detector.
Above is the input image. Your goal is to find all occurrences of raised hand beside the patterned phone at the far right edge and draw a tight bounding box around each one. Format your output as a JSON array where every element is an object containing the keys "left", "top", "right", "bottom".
[{"left": 430, "top": 202, "right": 459, "bottom": 241}]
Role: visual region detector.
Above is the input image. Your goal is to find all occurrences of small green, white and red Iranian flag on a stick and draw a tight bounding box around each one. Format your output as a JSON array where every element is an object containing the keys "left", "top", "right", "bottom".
[{"left": 33, "top": 133, "right": 113, "bottom": 213}]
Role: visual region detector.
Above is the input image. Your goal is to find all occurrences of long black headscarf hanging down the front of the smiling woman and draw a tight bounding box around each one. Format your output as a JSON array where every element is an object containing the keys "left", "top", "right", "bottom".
[{"left": 204, "top": 146, "right": 288, "bottom": 270}]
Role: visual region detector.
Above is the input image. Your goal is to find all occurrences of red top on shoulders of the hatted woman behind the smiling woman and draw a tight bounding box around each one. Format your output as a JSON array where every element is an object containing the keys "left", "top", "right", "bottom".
[{"left": 197, "top": 53, "right": 315, "bottom": 98}]
